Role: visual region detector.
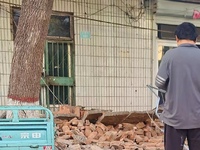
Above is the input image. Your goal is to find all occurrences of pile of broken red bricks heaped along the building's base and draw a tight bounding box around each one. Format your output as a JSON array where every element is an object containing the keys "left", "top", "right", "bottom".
[{"left": 55, "top": 106, "right": 164, "bottom": 150}]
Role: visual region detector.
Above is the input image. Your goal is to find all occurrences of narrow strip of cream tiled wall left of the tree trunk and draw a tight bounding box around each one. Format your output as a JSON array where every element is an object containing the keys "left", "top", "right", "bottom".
[{"left": 0, "top": 2, "right": 13, "bottom": 105}]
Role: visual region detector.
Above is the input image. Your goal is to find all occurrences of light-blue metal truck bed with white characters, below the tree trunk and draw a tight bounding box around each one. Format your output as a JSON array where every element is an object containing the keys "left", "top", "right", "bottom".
[{"left": 0, "top": 106, "right": 54, "bottom": 150}]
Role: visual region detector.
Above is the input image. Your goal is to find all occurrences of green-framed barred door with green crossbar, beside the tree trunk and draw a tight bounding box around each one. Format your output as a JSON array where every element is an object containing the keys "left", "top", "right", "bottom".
[{"left": 41, "top": 41, "right": 75, "bottom": 107}]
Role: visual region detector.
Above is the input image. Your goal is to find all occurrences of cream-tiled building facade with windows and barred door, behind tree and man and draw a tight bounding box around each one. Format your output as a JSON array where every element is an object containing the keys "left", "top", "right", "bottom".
[{"left": 0, "top": 0, "right": 200, "bottom": 111}]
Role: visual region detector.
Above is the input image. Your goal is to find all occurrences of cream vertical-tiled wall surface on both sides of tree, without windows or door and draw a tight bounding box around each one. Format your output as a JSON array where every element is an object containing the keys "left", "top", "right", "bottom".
[{"left": 0, "top": 0, "right": 152, "bottom": 111}]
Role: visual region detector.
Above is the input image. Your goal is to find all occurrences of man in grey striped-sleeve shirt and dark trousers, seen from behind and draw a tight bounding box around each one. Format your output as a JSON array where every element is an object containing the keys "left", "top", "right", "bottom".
[{"left": 156, "top": 22, "right": 200, "bottom": 150}]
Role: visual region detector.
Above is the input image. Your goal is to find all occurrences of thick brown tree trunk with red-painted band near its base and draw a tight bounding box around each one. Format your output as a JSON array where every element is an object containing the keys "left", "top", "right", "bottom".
[{"left": 8, "top": 0, "right": 53, "bottom": 117}]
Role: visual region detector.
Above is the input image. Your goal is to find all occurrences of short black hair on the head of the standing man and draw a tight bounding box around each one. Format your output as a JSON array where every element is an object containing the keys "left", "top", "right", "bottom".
[{"left": 175, "top": 22, "right": 198, "bottom": 42}]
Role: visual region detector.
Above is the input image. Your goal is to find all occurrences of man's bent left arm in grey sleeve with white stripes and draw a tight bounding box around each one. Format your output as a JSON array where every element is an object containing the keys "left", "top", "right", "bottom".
[{"left": 155, "top": 53, "right": 169, "bottom": 89}]
